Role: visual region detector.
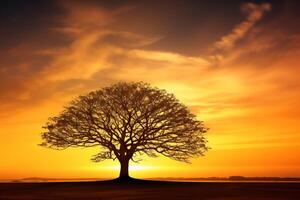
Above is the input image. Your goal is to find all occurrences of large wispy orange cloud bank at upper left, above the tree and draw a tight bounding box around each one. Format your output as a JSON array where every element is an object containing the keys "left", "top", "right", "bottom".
[{"left": 1, "top": 1, "right": 209, "bottom": 117}]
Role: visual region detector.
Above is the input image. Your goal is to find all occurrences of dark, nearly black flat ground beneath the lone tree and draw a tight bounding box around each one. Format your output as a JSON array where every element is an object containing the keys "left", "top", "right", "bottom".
[{"left": 0, "top": 180, "right": 300, "bottom": 200}]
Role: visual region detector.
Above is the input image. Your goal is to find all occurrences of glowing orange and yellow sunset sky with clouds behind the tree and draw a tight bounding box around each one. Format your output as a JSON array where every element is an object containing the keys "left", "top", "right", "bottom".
[{"left": 0, "top": 0, "right": 300, "bottom": 179}]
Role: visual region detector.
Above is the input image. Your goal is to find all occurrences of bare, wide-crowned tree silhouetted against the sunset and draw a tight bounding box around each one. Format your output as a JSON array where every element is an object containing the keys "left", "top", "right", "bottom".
[{"left": 41, "top": 82, "right": 208, "bottom": 179}]
